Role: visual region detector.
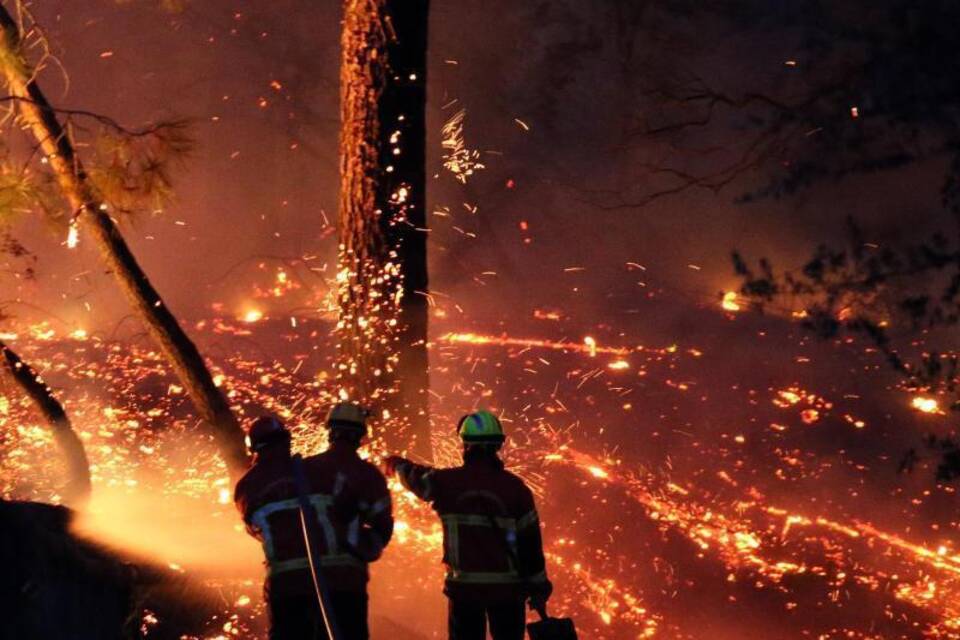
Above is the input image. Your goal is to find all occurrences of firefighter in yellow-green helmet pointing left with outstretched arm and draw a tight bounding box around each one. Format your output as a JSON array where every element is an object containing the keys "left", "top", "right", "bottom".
[{"left": 385, "top": 411, "right": 552, "bottom": 640}]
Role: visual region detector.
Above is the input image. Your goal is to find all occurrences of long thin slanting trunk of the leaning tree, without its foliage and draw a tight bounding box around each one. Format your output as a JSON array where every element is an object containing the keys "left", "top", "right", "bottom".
[{"left": 0, "top": 5, "right": 247, "bottom": 475}]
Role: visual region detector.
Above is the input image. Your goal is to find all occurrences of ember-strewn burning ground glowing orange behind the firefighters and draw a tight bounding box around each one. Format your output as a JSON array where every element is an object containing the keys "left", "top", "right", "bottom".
[{"left": 0, "top": 292, "right": 960, "bottom": 639}]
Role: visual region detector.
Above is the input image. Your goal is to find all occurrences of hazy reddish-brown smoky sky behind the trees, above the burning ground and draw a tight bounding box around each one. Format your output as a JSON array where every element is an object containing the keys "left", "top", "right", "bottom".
[{"left": 4, "top": 0, "right": 938, "bottom": 336}]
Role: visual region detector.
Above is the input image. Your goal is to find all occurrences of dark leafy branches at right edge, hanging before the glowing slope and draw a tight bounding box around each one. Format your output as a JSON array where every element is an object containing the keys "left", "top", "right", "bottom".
[{"left": 733, "top": 216, "right": 960, "bottom": 480}]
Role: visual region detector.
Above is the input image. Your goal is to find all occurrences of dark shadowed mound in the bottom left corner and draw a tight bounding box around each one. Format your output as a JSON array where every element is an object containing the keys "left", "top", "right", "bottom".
[{"left": 0, "top": 500, "right": 215, "bottom": 640}]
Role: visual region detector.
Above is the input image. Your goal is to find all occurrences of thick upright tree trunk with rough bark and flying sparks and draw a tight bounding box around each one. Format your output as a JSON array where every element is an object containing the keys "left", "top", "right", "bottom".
[{"left": 338, "top": 0, "right": 430, "bottom": 456}]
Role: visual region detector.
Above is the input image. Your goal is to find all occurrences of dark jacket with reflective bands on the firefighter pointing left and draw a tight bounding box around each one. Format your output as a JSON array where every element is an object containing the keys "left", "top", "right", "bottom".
[{"left": 396, "top": 453, "right": 552, "bottom": 604}]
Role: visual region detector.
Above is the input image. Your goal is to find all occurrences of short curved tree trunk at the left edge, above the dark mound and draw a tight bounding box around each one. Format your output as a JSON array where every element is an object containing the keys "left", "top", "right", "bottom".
[{"left": 0, "top": 342, "right": 90, "bottom": 509}]
